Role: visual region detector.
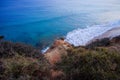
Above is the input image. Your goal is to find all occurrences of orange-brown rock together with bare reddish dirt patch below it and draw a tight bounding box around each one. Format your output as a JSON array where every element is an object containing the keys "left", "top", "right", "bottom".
[{"left": 44, "top": 39, "right": 72, "bottom": 80}]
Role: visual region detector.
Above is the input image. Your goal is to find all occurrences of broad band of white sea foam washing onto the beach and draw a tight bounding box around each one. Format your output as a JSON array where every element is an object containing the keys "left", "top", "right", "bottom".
[{"left": 65, "top": 20, "right": 120, "bottom": 46}]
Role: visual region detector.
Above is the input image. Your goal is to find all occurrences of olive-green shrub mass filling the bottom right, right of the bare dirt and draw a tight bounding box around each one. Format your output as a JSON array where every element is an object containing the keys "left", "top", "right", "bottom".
[{"left": 56, "top": 48, "right": 120, "bottom": 80}]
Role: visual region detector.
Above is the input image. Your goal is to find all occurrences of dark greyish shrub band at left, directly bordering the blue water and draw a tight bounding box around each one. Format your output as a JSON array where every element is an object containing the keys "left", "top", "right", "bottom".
[{"left": 0, "top": 41, "right": 43, "bottom": 58}]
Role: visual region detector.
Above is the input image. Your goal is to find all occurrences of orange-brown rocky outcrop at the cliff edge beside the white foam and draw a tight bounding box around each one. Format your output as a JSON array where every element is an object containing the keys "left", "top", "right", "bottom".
[{"left": 44, "top": 39, "right": 72, "bottom": 65}]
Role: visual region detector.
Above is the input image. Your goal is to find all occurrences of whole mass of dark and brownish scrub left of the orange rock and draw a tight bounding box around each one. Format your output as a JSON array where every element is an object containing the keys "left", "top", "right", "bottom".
[{"left": 0, "top": 40, "right": 50, "bottom": 80}]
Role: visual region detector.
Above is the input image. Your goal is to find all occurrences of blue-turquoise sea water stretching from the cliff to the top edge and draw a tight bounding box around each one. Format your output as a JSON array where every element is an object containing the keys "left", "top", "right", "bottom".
[{"left": 0, "top": 0, "right": 120, "bottom": 47}]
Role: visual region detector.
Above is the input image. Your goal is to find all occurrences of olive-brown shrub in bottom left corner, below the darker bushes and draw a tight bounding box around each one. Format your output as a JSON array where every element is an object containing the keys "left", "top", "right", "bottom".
[{"left": 0, "top": 55, "right": 50, "bottom": 80}]
